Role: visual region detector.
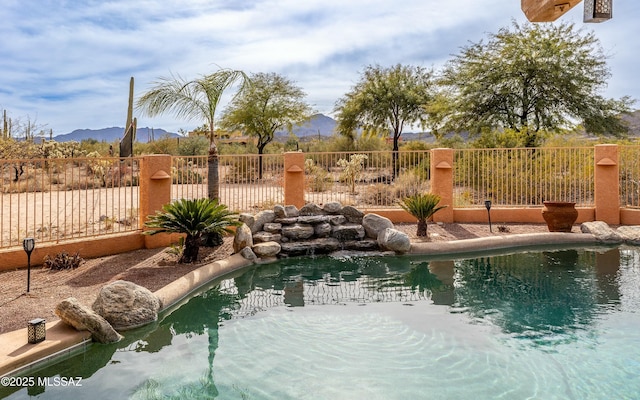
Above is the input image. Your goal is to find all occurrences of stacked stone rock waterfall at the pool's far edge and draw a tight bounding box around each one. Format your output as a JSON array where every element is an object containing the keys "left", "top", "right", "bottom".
[{"left": 234, "top": 202, "right": 411, "bottom": 259}]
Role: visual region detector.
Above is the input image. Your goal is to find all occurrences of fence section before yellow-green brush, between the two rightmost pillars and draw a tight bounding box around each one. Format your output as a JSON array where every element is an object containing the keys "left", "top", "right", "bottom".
[{"left": 454, "top": 147, "right": 594, "bottom": 207}]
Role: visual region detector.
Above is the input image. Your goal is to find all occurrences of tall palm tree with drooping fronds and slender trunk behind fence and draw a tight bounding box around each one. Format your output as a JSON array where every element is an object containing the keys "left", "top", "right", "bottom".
[{"left": 136, "top": 69, "right": 249, "bottom": 200}]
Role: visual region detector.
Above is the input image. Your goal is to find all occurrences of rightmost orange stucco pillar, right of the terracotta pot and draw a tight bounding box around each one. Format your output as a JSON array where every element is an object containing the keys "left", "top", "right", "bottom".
[{"left": 594, "top": 144, "right": 620, "bottom": 225}]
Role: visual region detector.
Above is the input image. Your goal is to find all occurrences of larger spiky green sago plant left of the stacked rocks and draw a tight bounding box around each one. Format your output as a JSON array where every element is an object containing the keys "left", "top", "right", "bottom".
[{"left": 144, "top": 198, "right": 240, "bottom": 263}]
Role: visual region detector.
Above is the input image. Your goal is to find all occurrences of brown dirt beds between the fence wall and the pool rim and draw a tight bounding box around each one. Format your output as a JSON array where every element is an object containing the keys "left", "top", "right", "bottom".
[{"left": 0, "top": 223, "right": 548, "bottom": 334}]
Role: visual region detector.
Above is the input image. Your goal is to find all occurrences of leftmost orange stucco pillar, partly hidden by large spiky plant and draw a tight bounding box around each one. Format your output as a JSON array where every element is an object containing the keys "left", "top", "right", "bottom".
[{"left": 140, "top": 154, "right": 171, "bottom": 249}]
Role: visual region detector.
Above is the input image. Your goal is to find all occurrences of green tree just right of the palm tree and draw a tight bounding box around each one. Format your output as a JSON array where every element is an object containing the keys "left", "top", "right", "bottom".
[{"left": 220, "top": 73, "right": 311, "bottom": 179}]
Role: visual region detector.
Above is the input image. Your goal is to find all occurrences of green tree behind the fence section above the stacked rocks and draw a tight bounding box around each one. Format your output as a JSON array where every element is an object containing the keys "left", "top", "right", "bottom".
[{"left": 334, "top": 64, "right": 433, "bottom": 177}]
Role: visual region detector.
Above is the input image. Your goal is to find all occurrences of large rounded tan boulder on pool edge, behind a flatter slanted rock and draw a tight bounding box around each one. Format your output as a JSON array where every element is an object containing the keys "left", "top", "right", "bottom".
[{"left": 92, "top": 281, "right": 161, "bottom": 330}]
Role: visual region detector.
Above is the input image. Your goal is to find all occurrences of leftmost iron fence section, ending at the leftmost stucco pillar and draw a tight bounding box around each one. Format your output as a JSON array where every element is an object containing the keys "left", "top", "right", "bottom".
[{"left": 0, "top": 158, "right": 139, "bottom": 248}]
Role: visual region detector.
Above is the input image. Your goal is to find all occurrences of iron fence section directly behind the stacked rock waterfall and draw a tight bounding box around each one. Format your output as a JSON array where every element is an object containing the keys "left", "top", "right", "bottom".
[{"left": 305, "top": 151, "right": 430, "bottom": 210}]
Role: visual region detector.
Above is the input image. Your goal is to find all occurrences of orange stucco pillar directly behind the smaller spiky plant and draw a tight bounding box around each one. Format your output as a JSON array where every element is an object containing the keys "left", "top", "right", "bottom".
[{"left": 431, "top": 149, "right": 453, "bottom": 223}]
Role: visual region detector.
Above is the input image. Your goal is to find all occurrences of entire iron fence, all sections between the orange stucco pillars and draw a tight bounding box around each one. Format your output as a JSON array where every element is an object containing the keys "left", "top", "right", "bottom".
[{"left": 0, "top": 146, "right": 640, "bottom": 248}]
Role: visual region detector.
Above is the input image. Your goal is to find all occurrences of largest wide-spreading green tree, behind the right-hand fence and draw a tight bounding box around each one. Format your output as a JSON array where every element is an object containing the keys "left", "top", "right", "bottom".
[{"left": 440, "top": 22, "right": 632, "bottom": 147}]
